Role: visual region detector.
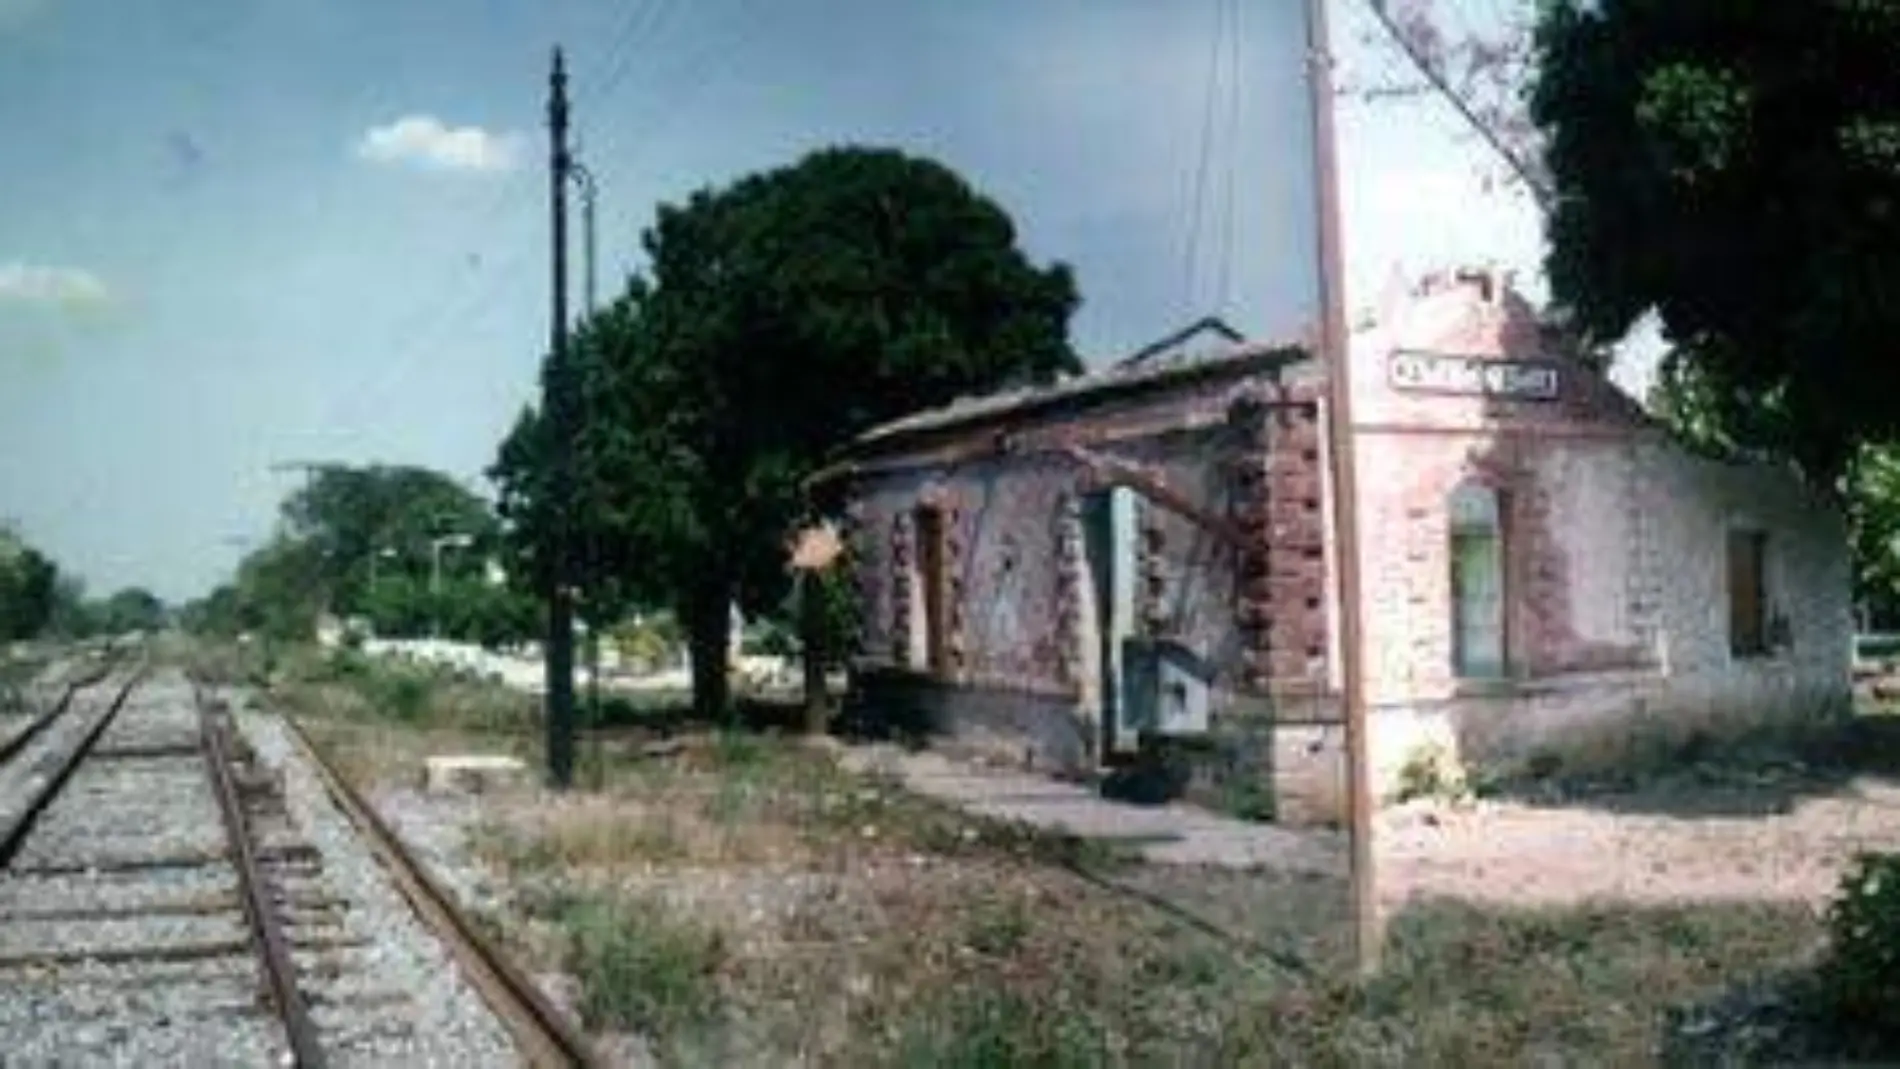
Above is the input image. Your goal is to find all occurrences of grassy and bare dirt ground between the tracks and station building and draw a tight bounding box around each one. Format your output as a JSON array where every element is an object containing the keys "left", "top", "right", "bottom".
[{"left": 275, "top": 656, "right": 1900, "bottom": 1065}]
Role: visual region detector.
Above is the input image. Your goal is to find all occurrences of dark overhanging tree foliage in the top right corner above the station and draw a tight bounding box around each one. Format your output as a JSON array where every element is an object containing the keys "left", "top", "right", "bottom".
[{"left": 1531, "top": 0, "right": 1900, "bottom": 484}]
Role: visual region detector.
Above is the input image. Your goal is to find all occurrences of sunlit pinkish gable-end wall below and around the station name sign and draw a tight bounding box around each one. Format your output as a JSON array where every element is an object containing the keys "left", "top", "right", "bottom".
[{"left": 1355, "top": 271, "right": 1851, "bottom": 808}]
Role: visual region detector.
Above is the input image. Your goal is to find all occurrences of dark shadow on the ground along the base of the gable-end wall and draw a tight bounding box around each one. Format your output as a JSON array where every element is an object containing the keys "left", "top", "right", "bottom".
[{"left": 1480, "top": 716, "right": 1900, "bottom": 818}]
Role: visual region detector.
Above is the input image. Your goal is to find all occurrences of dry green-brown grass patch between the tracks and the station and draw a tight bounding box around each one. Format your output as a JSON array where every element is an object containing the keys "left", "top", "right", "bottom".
[{"left": 241, "top": 656, "right": 1854, "bottom": 1067}]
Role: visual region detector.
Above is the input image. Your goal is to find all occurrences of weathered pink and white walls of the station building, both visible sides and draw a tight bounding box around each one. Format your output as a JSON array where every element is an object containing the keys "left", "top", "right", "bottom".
[{"left": 847, "top": 271, "right": 1851, "bottom": 822}]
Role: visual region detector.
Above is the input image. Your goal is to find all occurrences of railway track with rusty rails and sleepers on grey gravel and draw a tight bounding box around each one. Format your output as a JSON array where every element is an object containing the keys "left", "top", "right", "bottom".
[{"left": 0, "top": 665, "right": 547, "bottom": 1067}]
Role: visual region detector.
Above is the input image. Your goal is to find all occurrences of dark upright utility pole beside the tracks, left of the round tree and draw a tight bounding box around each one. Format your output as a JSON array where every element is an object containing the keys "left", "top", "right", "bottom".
[{"left": 543, "top": 46, "right": 574, "bottom": 790}]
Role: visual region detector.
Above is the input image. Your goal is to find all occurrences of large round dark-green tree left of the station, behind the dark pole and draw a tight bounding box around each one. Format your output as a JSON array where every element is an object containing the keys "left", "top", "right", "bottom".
[{"left": 492, "top": 148, "right": 1081, "bottom": 714}]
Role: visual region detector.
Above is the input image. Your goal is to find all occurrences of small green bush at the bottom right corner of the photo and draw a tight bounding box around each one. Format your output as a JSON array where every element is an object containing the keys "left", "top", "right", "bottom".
[{"left": 1822, "top": 854, "right": 1900, "bottom": 1039}]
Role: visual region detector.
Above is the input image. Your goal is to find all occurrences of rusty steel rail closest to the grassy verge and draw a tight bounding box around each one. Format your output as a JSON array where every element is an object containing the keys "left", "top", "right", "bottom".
[{"left": 283, "top": 716, "right": 604, "bottom": 1069}]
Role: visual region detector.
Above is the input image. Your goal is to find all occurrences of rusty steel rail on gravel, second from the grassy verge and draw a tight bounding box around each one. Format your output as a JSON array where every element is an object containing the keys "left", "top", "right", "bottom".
[{"left": 192, "top": 687, "right": 323, "bottom": 1069}]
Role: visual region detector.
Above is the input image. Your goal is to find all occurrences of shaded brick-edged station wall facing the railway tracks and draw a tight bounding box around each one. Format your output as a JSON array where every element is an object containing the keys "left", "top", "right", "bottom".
[{"left": 849, "top": 362, "right": 1328, "bottom": 786}]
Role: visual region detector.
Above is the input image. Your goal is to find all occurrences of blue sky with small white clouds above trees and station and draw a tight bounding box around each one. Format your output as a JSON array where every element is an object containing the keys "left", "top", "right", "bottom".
[{"left": 0, "top": 0, "right": 1618, "bottom": 598}]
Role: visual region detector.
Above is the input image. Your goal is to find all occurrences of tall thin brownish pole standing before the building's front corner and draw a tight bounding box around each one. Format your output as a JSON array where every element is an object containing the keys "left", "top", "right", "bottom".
[{"left": 1307, "top": 0, "right": 1385, "bottom": 976}]
